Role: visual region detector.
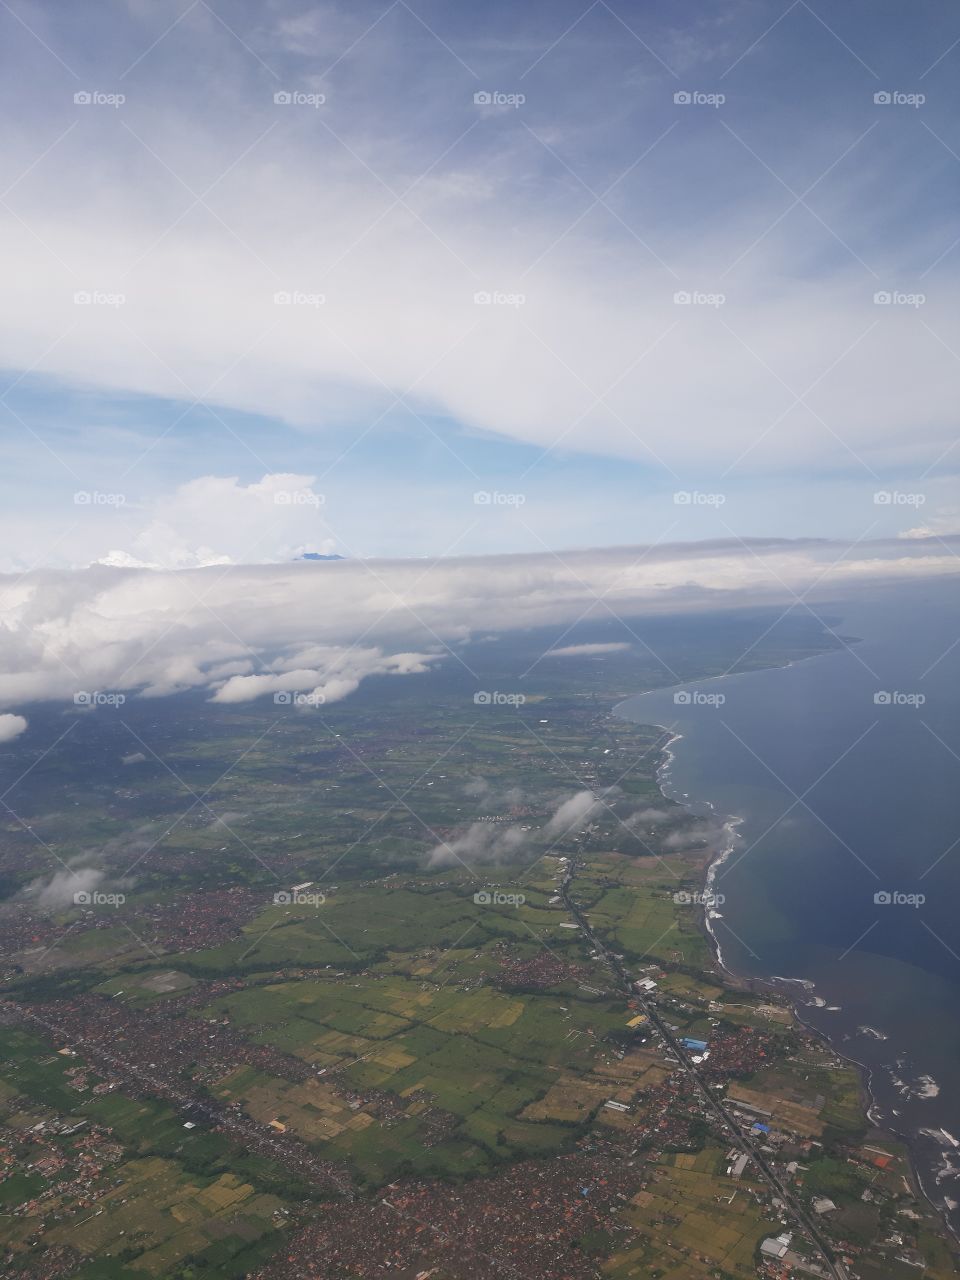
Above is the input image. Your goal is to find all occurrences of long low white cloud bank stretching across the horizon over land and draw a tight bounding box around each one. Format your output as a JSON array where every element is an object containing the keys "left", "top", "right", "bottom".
[{"left": 0, "top": 539, "right": 960, "bottom": 708}]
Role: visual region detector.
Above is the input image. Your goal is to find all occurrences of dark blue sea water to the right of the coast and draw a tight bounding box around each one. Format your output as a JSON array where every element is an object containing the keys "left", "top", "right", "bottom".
[{"left": 618, "top": 584, "right": 960, "bottom": 1230}]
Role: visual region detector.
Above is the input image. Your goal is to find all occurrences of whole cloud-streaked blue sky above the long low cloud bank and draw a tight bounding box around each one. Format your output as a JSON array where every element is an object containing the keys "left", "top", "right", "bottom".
[{"left": 0, "top": 0, "right": 960, "bottom": 570}]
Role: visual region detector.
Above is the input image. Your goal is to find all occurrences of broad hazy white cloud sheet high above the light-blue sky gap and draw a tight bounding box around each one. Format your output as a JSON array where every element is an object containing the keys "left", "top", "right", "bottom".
[{"left": 0, "top": 3, "right": 960, "bottom": 481}]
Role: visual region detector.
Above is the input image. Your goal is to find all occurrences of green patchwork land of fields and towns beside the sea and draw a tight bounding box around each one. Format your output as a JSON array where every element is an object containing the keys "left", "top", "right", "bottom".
[{"left": 0, "top": 617, "right": 957, "bottom": 1280}]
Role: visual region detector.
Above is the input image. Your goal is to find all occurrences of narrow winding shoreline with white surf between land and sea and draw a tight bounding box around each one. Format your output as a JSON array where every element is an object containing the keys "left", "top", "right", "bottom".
[{"left": 612, "top": 691, "right": 960, "bottom": 1244}]
